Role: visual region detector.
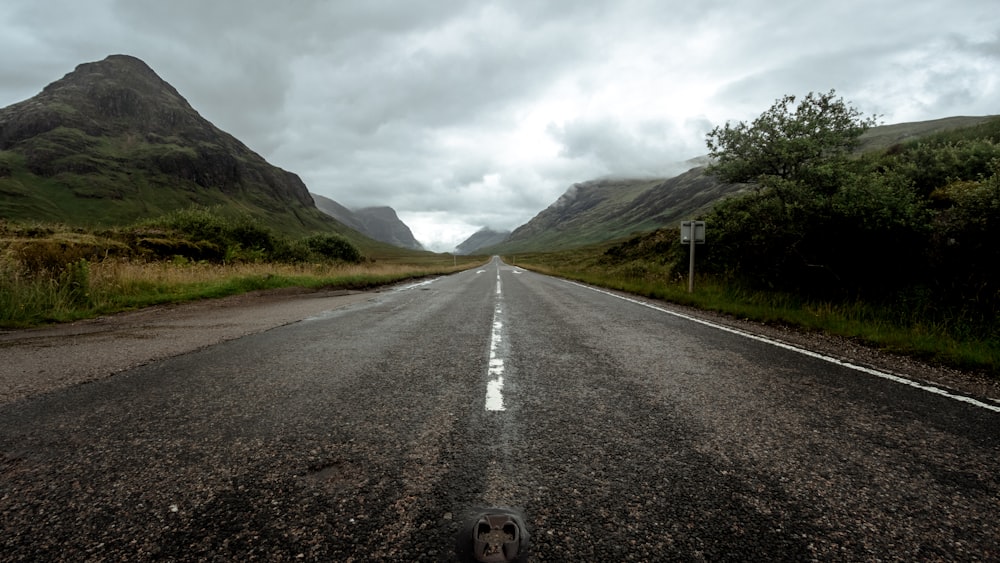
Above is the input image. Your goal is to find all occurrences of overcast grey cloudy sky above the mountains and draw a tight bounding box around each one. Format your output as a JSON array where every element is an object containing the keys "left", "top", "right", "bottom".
[{"left": 0, "top": 0, "right": 1000, "bottom": 250}]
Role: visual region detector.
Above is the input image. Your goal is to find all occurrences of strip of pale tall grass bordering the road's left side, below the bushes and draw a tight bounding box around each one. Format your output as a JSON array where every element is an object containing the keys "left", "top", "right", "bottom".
[{"left": 0, "top": 257, "right": 482, "bottom": 328}]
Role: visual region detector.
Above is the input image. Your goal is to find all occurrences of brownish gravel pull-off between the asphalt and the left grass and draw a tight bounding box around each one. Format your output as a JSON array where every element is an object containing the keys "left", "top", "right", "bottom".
[{"left": 0, "top": 288, "right": 374, "bottom": 404}]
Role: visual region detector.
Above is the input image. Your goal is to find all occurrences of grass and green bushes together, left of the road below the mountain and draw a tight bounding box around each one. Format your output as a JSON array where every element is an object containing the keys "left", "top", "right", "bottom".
[{"left": 0, "top": 207, "right": 481, "bottom": 328}]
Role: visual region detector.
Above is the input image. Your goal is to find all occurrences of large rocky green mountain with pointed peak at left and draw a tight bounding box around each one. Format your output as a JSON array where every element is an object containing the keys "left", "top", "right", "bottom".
[{"left": 0, "top": 55, "right": 360, "bottom": 238}]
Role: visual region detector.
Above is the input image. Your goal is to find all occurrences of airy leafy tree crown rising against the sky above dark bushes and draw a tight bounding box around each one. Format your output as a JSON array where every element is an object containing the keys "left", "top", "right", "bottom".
[{"left": 706, "top": 90, "right": 876, "bottom": 184}]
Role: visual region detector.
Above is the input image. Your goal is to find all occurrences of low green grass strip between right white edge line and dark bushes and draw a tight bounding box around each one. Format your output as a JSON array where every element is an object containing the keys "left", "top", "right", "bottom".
[{"left": 507, "top": 252, "right": 1000, "bottom": 377}]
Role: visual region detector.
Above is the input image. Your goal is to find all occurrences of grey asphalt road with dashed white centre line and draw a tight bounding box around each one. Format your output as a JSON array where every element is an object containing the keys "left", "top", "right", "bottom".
[{"left": 0, "top": 261, "right": 1000, "bottom": 561}]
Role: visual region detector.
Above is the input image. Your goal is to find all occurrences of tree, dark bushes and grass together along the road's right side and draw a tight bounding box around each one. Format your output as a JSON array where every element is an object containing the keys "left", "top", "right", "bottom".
[{"left": 513, "top": 92, "right": 1000, "bottom": 376}]
